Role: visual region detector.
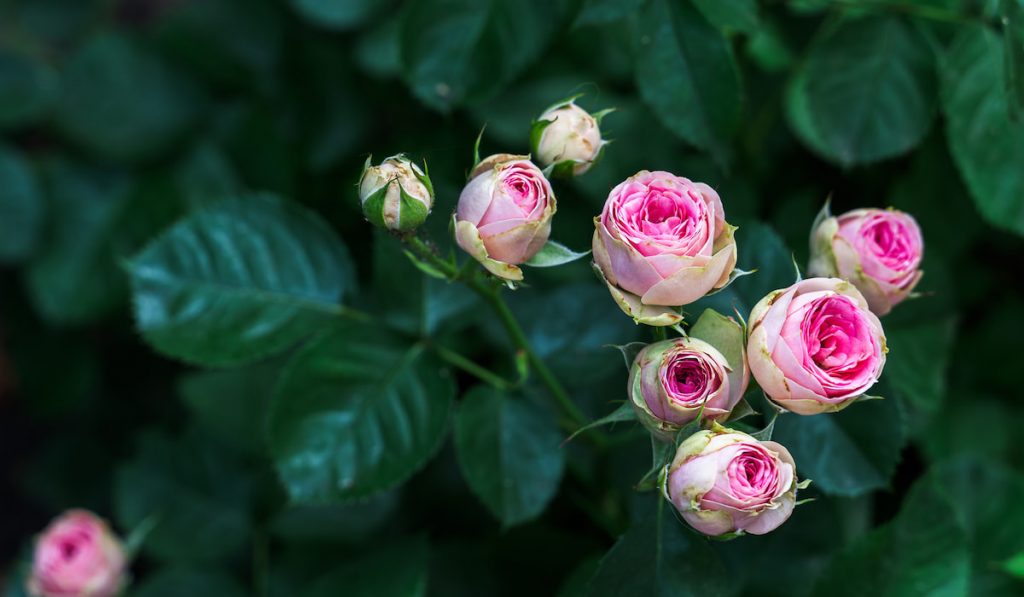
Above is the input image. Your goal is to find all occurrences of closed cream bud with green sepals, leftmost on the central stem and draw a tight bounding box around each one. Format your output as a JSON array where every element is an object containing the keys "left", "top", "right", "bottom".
[{"left": 359, "top": 154, "right": 434, "bottom": 231}]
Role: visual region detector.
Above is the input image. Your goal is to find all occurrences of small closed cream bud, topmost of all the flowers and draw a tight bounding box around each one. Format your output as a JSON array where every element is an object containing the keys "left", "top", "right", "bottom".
[{"left": 529, "top": 99, "right": 607, "bottom": 176}]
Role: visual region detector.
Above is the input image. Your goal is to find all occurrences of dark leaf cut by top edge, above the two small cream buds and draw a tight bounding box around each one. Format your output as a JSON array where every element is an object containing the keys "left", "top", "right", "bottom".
[{"left": 399, "top": 0, "right": 563, "bottom": 112}]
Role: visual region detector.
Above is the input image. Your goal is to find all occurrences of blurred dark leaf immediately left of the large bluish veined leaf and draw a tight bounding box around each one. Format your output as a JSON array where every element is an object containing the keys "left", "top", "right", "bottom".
[{"left": 28, "top": 161, "right": 131, "bottom": 325}]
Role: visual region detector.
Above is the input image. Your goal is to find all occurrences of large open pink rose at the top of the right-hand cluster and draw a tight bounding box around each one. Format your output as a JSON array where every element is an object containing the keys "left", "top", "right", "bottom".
[{"left": 594, "top": 170, "right": 736, "bottom": 326}]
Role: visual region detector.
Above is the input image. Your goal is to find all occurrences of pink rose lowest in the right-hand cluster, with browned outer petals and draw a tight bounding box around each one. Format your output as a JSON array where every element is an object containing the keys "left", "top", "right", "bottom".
[{"left": 665, "top": 424, "right": 803, "bottom": 537}]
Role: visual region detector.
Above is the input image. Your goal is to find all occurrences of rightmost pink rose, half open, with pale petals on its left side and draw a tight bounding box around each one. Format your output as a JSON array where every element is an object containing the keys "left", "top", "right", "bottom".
[{"left": 808, "top": 208, "right": 925, "bottom": 316}]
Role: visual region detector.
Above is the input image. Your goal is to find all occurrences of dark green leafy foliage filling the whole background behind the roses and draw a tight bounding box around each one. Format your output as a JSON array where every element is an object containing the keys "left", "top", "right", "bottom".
[{"left": 0, "top": 0, "right": 1024, "bottom": 597}]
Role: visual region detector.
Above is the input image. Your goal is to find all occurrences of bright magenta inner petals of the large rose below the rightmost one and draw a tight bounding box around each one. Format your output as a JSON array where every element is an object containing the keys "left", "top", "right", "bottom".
[{"left": 801, "top": 296, "right": 880, "bottom": 394}]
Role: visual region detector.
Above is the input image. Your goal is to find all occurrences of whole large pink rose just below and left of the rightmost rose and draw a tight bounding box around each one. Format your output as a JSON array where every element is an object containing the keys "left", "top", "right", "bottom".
[{"left": 746, "top": 278, "right": 887, "bottom": 415}]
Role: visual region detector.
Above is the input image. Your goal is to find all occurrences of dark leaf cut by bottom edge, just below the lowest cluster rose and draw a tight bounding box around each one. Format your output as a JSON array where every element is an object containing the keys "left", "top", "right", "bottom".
[{"left": 588, "top": 495, "right": 733, "bottom": 597}]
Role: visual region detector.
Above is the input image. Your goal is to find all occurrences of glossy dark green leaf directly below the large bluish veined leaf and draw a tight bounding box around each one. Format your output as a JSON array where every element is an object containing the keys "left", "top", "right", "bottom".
[{"left": 268, "top": 324, "right": 455, "bottom": 503}]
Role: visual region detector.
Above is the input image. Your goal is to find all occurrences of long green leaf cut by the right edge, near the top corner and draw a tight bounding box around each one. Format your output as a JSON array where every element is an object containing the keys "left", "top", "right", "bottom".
[{"left": 941, "top": 26, "right": 1024, "bottom": 234}]
